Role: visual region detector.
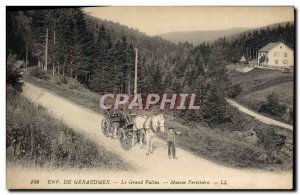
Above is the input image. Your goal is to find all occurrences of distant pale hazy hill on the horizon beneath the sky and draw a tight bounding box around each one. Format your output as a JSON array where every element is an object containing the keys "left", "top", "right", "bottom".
[{"left": 158, "top": 28, "right": 249, "bottom": 45}]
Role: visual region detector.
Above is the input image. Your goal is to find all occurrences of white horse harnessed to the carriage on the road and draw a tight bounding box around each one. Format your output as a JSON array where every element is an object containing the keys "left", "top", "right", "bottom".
[{"left": 132, "top": 114, "right": 165, "bottom": 155}]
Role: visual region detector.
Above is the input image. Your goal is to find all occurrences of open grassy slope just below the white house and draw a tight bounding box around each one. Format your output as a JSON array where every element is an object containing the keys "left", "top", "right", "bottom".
[{"left": 228, "top": 68, "right": 294, "bottom": 124}]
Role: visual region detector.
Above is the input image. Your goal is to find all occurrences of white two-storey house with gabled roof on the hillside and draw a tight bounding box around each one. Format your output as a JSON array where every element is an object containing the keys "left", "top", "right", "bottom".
[{"left": 257, "top": 42, "right": 294, "bottom": 68}]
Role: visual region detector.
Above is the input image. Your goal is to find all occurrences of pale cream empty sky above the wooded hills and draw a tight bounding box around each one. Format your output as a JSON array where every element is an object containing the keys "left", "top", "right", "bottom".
[{"left": 84, "top": 6, "right": 294, "bottom": 35}]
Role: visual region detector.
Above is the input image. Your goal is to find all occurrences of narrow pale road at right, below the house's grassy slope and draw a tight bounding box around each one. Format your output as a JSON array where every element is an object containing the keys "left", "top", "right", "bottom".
[{"left": 226, "top": 99, "right": 293, "bottom": 130}]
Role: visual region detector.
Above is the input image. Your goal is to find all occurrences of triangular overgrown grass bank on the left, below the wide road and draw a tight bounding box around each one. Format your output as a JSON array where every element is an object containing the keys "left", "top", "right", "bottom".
[{"left": 6, "top": 87, "right": 129, "bottom": 170}]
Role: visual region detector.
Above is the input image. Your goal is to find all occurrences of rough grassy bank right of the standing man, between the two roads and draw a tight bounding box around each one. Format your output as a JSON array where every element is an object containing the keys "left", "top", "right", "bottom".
[{"left": 160, "top": 108, "right": 293, "bottom": 171}]
